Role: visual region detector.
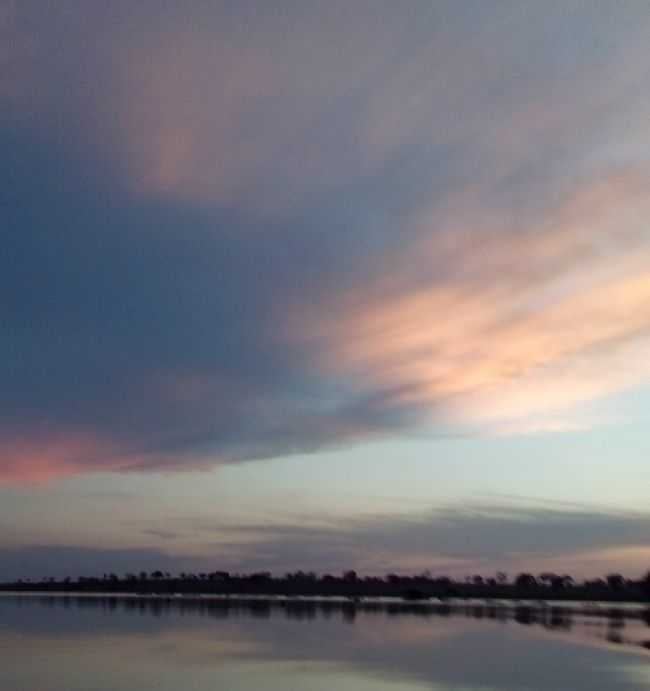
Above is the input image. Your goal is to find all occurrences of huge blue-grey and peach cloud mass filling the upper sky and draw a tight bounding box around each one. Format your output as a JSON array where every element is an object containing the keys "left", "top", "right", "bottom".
[{"left": 0, "top": 0, "right": 650, "bottom": 482}]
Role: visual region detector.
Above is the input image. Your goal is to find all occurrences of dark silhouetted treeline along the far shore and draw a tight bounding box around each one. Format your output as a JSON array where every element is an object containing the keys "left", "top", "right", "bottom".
[{"left": 0, "top": 571, "right": 650, "bottom": 602}]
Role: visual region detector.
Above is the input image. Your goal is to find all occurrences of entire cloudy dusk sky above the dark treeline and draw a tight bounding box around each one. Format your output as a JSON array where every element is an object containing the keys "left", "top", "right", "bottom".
[{"left": 0, "top": 0, "right": 650, "bottom": 579}]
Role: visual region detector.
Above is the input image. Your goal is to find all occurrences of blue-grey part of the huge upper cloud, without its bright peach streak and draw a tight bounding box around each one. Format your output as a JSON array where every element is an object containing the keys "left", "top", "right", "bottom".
[{"left": 0, "top": 0, "right": 650, "bottom": 480}]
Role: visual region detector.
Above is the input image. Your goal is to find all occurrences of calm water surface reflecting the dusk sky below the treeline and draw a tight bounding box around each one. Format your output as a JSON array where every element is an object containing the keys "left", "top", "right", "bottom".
[{"left": 0, "top": 596, "right": 650, "bottom": 691}]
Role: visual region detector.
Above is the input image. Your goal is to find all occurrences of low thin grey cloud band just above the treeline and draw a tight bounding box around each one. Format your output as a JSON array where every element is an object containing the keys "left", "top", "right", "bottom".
[{"left": 0, "top": 501, "right": 650, "bottom": 578}]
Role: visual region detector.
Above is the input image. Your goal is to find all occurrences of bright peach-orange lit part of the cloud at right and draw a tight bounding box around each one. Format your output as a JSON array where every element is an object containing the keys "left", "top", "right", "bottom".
[{"left": 296, "top": 171, "right": 650, "bottom": 430}]
